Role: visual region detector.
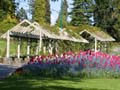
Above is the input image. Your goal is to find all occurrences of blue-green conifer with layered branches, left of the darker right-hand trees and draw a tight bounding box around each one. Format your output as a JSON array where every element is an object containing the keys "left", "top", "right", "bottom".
[{"left": 70, "top": 0, "right": 93, "bottom": 26}]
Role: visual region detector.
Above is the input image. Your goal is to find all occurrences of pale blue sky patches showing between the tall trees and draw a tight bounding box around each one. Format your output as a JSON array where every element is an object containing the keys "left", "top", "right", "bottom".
[{"left": 16, "top": 0, "right": 72, "bottom": 25}]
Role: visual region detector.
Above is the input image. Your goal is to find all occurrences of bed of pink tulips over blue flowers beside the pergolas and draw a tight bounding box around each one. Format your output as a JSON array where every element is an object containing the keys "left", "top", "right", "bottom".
[{"left": 21, "top": 50, "right": 120, "bottom": 78}]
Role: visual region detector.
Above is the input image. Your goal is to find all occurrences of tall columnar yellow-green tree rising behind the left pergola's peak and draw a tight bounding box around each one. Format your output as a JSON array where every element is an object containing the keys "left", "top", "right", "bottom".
[{"left": 32, "top": 0, "right": 50, "bottom": 25}]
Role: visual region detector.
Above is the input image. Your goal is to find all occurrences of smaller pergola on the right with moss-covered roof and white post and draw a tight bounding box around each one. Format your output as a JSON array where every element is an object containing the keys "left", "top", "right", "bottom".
[{"left": 80, "top": 29, "right": 115, "bottom": 52}]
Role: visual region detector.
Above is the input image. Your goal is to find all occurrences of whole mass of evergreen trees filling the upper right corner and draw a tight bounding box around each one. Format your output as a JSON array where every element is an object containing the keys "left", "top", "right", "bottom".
[{"left": 70, "top": 0, "right": 120, "bottom": 41}]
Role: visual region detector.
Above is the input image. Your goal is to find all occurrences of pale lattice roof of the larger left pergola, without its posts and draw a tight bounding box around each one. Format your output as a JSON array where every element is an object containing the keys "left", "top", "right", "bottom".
[{"left": 1, "top": 20, "right": 88, "bottom": 43}]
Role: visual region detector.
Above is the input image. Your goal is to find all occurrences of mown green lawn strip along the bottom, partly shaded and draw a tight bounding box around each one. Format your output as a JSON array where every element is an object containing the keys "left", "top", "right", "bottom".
[{"left": 0, "top": 77, "right": 120, "bottom": 90}]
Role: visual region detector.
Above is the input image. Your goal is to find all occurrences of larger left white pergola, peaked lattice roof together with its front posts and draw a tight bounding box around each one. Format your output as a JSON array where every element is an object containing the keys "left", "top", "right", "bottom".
[{"left": 1, "top": 20, "right": 88, "bottom": 58}]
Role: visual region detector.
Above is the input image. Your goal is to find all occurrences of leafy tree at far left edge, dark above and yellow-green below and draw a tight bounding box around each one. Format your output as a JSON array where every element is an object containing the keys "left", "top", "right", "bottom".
[{"left": 0, "top": 0, "right": 17, "bottom": 33}]
